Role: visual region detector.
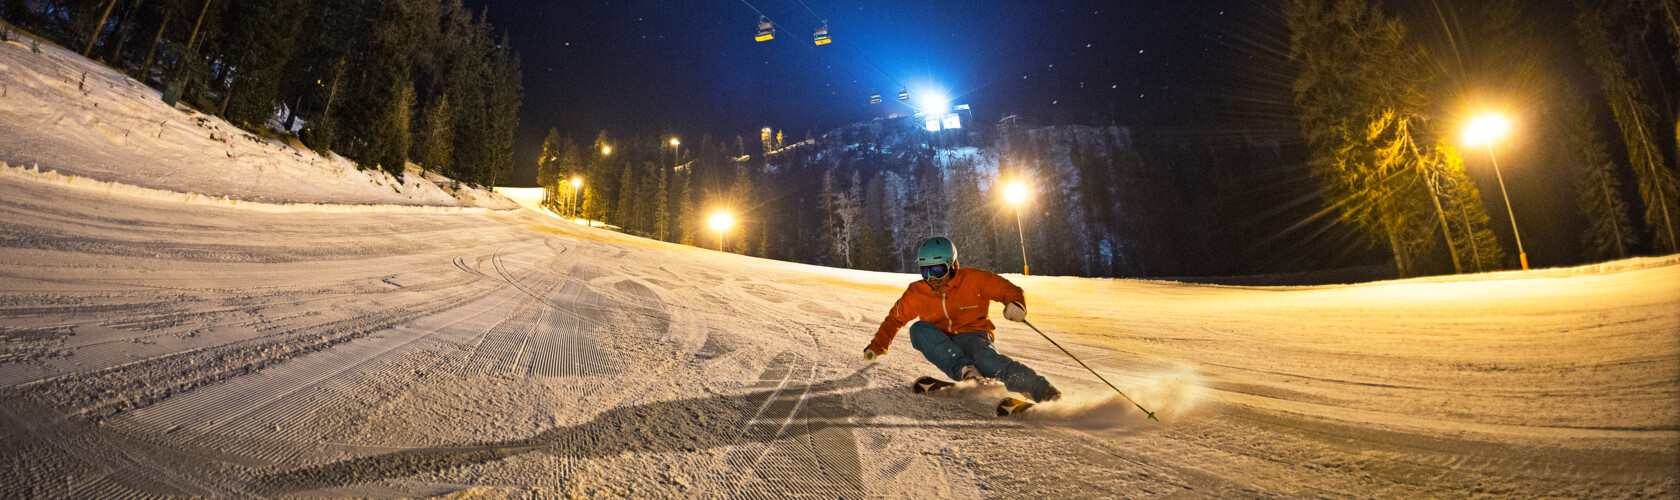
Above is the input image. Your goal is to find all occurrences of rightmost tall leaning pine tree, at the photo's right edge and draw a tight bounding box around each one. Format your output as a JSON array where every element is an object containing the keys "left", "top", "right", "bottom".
[{"left": 1576, "top": 3, "right": 1680, "bottom": 253}]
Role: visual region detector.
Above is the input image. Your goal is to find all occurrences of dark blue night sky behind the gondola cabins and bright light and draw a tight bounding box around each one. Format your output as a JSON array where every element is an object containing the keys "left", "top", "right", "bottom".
[{"left": 467, "top": 0, "right": 1280, "bottom": 183}]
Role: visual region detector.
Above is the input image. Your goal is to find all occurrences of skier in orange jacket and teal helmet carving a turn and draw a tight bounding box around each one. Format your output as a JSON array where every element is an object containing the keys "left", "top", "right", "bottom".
[{"left": 864, "top": 237, "right": 1062, "bottom": 403}]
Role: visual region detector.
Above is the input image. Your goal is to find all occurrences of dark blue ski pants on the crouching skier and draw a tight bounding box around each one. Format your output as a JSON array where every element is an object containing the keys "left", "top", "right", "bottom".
[{"left": 911, "top": 320, "right": 1055, "bottom": 401}]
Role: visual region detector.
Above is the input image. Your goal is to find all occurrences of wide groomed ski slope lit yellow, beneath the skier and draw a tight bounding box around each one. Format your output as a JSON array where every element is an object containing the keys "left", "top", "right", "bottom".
[{"left": 0, "top": 29, "right": 1680, "bottom": 498}]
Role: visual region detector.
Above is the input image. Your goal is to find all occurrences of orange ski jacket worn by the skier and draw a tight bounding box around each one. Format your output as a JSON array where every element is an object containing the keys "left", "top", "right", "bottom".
[{"left": 869, "top": 267, "right": 1026, "bottom": 354}]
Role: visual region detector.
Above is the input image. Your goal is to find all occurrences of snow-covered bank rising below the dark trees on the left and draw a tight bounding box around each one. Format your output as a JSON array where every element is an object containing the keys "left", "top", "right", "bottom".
[{"left": 0, "top": 32, "right": 517, "bottom": 210}]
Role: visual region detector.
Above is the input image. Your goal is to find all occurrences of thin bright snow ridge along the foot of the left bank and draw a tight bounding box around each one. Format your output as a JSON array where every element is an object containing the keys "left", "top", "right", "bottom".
[{"left": 0, "top": 161, "right": 492, "bottom": 213}]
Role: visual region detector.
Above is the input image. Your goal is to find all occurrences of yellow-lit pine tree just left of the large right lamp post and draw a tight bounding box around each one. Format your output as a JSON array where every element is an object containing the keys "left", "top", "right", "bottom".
[{"left": 1287, "top": 0, "right": 1457, "bottom": 275}]
